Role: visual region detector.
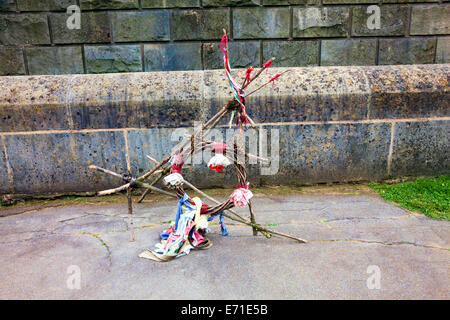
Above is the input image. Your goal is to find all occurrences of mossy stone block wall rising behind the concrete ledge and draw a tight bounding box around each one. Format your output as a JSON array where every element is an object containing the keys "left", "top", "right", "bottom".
[{"left": 0, "top": 0, "right": 450, "bottom": 75}]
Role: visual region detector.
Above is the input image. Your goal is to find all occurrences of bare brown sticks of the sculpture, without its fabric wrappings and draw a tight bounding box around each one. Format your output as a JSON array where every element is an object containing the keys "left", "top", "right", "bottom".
[{"left": 89, "top": 30, "right": 306, "bottom": 243}]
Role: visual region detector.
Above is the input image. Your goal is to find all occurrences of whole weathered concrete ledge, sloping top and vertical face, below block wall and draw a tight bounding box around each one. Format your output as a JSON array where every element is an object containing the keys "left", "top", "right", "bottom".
[{"left": 0, "top": 64, "right": 450, "bottom": 194}]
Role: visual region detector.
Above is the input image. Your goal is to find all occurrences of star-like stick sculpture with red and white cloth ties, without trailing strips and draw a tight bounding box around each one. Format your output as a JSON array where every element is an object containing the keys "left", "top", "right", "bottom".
[{"left": 89, "top": 30, "right": 306, "bottom": 261}]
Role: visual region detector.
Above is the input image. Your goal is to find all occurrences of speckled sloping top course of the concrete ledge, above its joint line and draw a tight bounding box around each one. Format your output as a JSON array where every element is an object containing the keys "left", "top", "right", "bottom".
[{"left": 0, "top": 64, "right": 450, "bottom": 132}]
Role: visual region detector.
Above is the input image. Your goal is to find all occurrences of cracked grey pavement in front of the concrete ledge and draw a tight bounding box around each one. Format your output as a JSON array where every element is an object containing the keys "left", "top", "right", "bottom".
[{"left": 0, "top": 186, "right": 450, "bottom": 299}]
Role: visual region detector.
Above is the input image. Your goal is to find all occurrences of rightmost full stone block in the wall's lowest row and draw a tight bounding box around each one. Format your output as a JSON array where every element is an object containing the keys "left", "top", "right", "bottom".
[{"left": 378, "top": 38, "right": 436, "bottom": 65}]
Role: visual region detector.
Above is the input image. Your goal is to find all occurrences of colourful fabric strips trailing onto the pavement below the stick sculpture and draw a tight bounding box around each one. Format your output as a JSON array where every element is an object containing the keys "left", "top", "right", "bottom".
[{"left": 139, "top": 194, "right": 212, "bottom": 262}]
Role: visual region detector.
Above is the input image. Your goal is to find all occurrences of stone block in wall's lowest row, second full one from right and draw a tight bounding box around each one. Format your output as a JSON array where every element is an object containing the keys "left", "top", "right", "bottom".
[{"left": 320, "top": 39, "right": 377, "bottom": 66}]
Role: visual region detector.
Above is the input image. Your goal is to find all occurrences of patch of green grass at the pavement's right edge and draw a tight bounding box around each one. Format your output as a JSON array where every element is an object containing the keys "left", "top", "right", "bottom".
[{"left": 369, "top": 175, "right": 450, "bottom": 221}]
